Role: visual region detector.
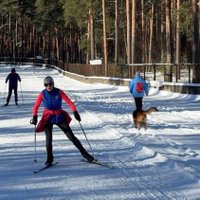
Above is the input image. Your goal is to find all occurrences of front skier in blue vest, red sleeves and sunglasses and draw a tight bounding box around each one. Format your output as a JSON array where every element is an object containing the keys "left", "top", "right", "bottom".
[{"left": 31, "top": 76, "right": 94, "bottom": 165}]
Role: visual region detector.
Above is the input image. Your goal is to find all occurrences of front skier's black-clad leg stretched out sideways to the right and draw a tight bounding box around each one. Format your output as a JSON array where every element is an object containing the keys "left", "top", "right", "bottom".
[{"left": 58, "top": 122, "right": 94, "bottom": 162}]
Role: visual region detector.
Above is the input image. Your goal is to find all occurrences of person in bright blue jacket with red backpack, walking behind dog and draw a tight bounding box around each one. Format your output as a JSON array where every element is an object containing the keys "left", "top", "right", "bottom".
[{"left": 129, "top": 71, "right": 149, "bottom": 110}]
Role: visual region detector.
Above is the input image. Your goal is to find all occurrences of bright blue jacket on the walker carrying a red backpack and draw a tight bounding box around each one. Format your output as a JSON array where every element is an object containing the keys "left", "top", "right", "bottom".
[{"left": 129, "top": 74, "right": 149, "bottom": 97}]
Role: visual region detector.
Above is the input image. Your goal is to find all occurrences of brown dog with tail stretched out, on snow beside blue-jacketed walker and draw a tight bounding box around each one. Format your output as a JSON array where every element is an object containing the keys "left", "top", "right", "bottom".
[{"left": 133, "top": 107, "right": 158, "bottom": 129}]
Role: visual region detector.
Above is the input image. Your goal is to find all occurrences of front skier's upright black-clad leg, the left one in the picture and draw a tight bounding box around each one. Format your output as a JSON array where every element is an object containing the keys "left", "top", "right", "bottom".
[{"left": 44, "top": 123, "right": 53, "bottom": 165}]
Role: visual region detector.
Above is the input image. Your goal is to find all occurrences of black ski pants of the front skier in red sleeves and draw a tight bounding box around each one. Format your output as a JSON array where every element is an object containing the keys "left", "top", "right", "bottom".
[{"left": 44, "top": 122, "right": 88, "bottom": 159}]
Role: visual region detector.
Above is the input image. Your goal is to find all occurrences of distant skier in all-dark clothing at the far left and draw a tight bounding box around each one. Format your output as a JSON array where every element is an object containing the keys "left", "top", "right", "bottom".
[{"left": 5, "top": 68, "right": 21, "bottom": 106}]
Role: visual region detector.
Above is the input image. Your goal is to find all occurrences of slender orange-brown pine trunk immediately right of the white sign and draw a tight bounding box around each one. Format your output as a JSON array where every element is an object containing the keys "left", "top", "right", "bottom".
[{"left": 102, "top": 0, "right": 108, "bottom": 76}]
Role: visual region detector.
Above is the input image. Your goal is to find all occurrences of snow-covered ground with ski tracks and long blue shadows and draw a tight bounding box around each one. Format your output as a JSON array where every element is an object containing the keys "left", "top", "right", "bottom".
[{"left": 0, "top": 66, "right": 200, "bottom": 200}]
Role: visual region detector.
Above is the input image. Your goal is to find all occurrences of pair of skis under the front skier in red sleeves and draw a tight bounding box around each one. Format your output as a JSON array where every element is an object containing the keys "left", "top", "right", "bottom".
[{"left": 33, "top": 160, "right": 114, "bottom": 174}]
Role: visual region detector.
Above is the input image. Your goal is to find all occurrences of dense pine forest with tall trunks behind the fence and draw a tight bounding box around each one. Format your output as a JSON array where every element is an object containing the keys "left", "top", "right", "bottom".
[{"left": 0, "top": 0, "right": 200, "bottom": 82}]
